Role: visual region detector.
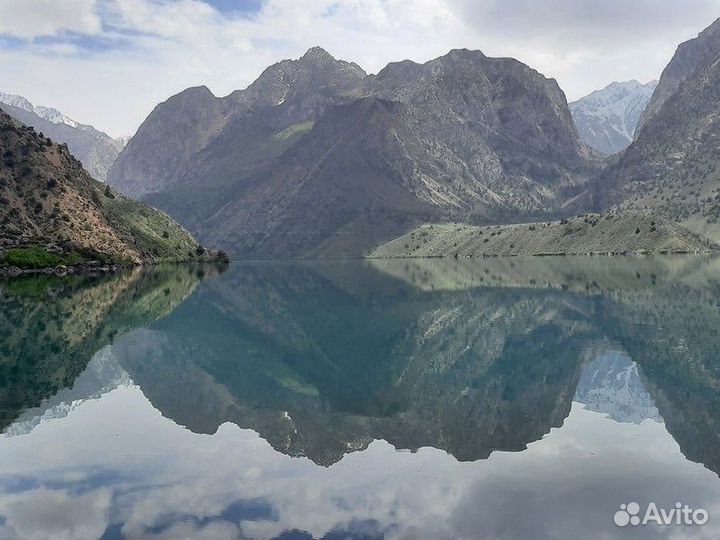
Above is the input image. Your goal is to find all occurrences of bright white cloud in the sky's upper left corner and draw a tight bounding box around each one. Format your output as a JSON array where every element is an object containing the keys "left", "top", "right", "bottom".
[{"left": 0, "top": 0, "right": 102, "bottom": 38}]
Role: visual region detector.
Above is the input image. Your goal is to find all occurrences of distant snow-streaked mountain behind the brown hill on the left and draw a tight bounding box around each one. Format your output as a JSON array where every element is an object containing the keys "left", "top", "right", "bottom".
[{"left": 0, "top": 92, "right": 126, "bottom": 182}]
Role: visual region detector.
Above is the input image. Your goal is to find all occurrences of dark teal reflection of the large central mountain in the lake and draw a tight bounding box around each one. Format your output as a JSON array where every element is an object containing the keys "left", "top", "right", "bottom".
[{"left": 113, "top": 265, "right": 598, "bottom": 465}]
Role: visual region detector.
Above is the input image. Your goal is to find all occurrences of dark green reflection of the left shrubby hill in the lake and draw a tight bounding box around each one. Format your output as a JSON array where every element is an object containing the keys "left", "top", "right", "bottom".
[{"left": 0, "top": 267, "right": 205, "bottom": 429}]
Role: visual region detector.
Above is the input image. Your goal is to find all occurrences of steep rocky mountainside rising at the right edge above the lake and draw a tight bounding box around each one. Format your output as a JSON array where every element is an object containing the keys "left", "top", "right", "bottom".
[{"left": 593, "top": 19, "right": 720, "bottom": 242}]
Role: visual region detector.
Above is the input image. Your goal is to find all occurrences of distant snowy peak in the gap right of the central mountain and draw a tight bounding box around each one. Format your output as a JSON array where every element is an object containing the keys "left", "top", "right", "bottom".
[{"left": 570, "top": 80, "right": 658, "bottom": 155}]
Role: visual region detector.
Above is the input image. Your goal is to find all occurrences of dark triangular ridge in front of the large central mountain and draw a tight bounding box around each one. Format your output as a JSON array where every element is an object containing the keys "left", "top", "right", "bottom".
[{"left": 200, "top": 99, "right": 430, "bottom": 258}]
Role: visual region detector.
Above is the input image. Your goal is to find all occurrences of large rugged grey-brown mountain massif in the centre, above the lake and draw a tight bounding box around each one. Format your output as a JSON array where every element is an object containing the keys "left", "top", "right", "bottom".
[{"left": 108, "top": 47, "right": 595, "bottom": 257}]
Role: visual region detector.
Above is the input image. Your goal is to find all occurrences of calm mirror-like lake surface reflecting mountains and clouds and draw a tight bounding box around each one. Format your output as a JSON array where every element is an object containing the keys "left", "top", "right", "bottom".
[{"left": 0, "top": 257, "right": 720, "bottom": 540}]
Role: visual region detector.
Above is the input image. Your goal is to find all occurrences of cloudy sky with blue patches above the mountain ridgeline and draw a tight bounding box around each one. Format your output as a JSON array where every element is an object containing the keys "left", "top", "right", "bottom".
[{"left": 0, "top": 0, "right": 720, "bottom": 136}]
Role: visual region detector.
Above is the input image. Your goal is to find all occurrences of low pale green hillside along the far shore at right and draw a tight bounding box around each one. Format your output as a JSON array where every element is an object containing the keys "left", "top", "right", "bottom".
[{"left": 370, "top": 214, "right": 718, "bottom": 258}]
